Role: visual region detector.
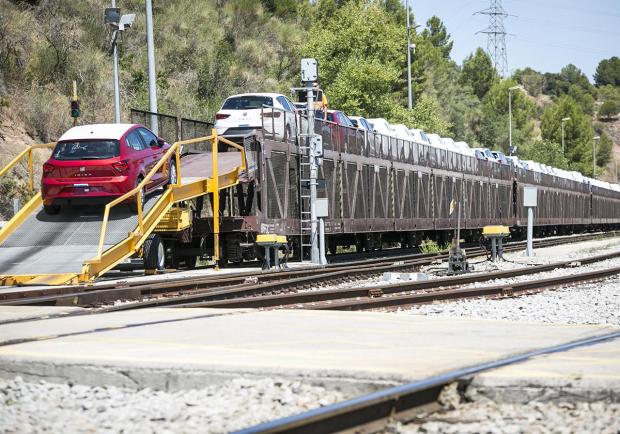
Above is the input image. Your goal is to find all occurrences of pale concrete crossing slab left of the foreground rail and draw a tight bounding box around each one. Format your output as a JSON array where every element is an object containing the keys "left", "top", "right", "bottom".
[{"left": 0, "top": 308, "right": 620, "bottom": 392}]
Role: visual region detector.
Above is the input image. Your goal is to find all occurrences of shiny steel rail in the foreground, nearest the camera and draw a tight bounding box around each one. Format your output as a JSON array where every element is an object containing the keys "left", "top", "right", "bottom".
[{"left": 236, "top": 331, "right": 620, "bottom": 434}]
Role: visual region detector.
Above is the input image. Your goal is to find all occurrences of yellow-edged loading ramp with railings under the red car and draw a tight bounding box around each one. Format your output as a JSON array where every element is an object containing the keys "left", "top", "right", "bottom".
[{"left": 0, "top": 130, "right": 246, "bottom": 285}]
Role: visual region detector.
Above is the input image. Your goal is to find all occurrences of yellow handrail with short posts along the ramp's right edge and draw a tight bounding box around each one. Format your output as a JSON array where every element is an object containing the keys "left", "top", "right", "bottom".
[{"left": 94, "top": 129, "right": 247, "bottom": 261}]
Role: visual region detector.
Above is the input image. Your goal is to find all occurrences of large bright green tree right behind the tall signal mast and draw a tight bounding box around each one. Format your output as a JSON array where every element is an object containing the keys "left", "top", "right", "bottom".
[{"left": 301, "top": 1, "right": 405, "bottom": 117}]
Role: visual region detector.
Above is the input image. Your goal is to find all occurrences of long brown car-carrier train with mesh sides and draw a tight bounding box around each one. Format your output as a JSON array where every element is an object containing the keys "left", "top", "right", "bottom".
[{"left": 134, "top": 109, "right": 620, "bottom": 262}]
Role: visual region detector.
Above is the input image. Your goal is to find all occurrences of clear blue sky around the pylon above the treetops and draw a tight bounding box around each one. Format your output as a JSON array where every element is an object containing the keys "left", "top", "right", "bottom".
[{"left": 412, "top": 0, "right": 620, "bottom": 81}]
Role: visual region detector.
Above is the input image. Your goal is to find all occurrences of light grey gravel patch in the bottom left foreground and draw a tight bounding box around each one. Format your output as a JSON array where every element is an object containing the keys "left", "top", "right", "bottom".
[{"left": 0, "top": 377, "right": 345, "bottom": 433}]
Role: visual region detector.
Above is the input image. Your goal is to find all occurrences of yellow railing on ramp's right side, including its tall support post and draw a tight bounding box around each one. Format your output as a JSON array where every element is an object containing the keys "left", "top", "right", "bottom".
[{"left": 89, "top": 129, "right": 247, "bottom": 266}]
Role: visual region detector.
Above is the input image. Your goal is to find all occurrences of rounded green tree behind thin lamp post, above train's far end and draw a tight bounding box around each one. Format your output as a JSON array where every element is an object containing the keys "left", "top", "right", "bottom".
[{"left": 540, "top": 95, "right": 606, "bottom": 174}]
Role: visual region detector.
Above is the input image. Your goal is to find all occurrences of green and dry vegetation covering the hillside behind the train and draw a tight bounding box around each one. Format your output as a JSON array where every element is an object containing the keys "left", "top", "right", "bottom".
[{"left": 0, "top": 0, "right": 620, "bottom": 217}]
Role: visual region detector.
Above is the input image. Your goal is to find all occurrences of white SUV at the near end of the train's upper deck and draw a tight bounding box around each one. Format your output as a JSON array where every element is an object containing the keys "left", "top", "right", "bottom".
[{"left": 215, "top": 93, "right": 298, "bottom": 142}]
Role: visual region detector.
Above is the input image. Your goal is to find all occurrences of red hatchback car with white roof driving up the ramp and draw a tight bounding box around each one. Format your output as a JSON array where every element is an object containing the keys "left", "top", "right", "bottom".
[{"left": 41, "top": 124, "right": 177, "bottom": 214}]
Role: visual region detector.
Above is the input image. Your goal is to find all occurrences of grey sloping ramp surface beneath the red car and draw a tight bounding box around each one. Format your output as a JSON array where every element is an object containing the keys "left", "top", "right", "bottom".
[{"left": 0, "top": 191, "right": 160, "bottom": 275}]
